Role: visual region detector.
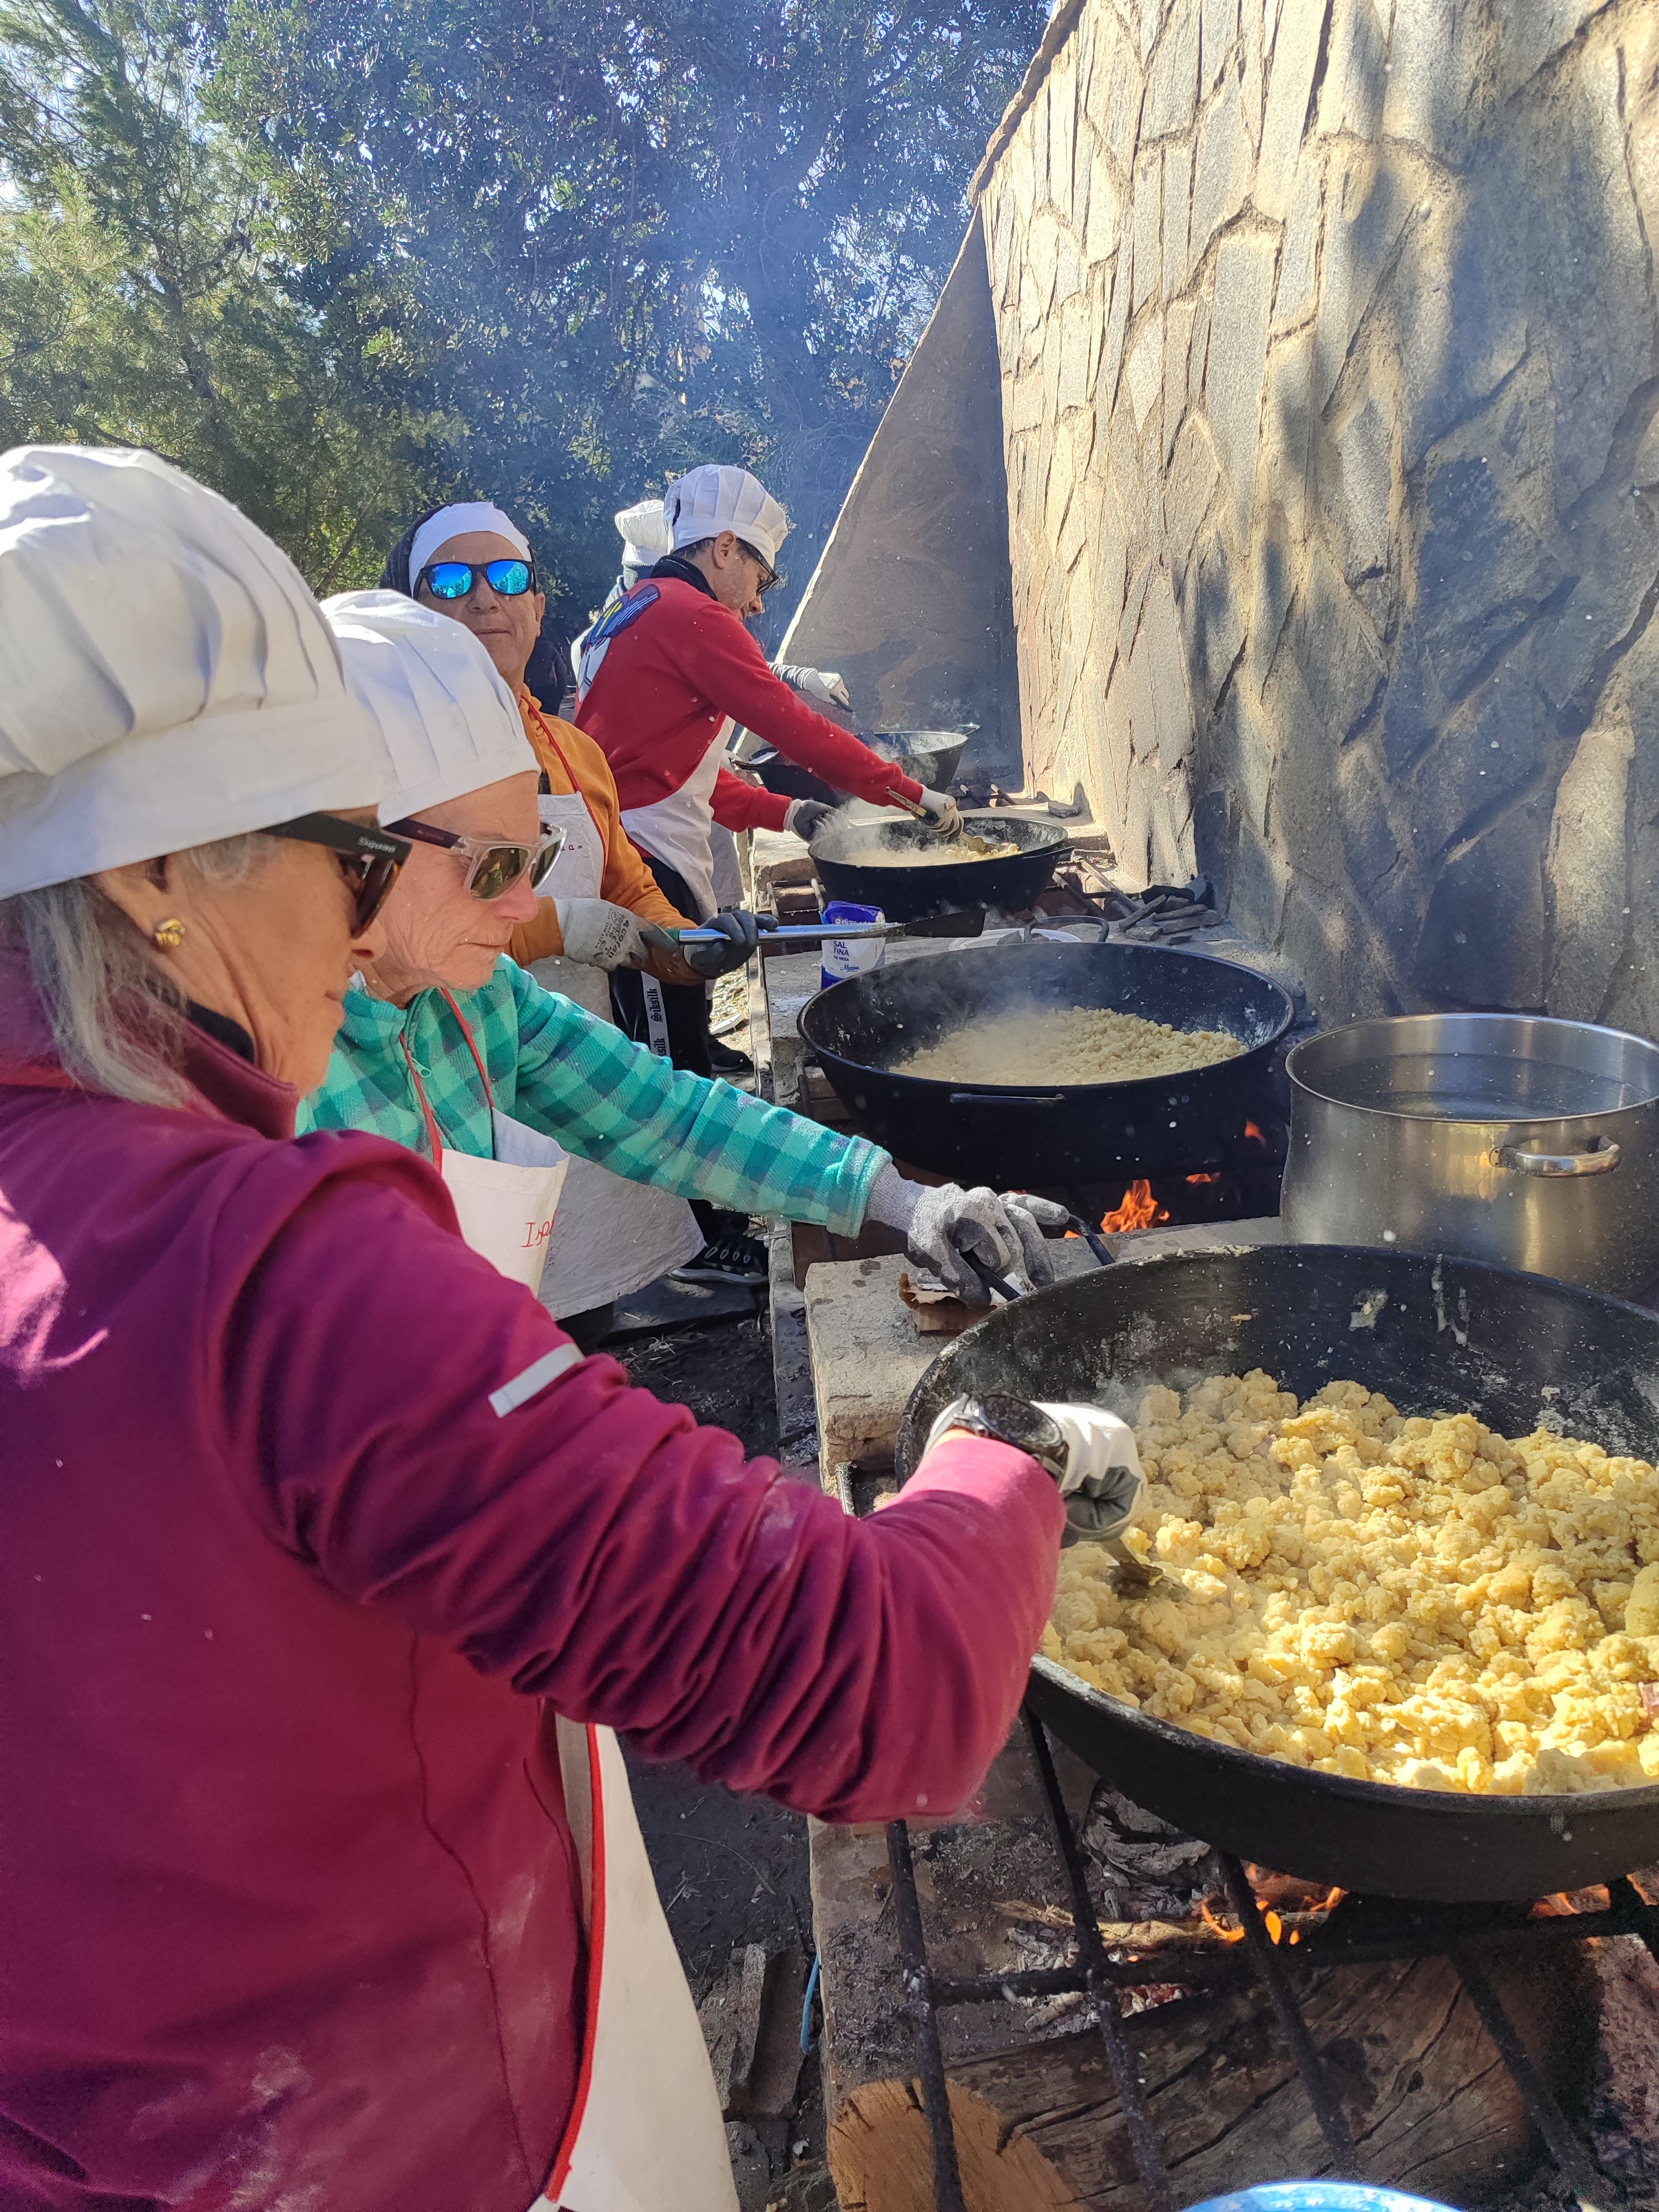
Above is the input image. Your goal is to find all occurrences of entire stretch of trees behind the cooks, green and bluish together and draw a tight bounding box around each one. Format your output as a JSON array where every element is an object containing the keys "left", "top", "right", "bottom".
[{"left": 0, "top": 0, "right": 1046, "bottom": 608}]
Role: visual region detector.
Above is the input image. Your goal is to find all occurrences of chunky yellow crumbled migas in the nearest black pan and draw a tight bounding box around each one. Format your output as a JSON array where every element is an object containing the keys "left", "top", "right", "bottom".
[{"left": 1042, "top": 1369, "right": 1659, "bottom": 1796}]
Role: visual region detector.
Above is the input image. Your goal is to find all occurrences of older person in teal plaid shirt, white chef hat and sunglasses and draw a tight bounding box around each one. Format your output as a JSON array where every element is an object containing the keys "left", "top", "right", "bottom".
[{"left": 299, "top": 593, "right": 1066, "bottom": 1336}]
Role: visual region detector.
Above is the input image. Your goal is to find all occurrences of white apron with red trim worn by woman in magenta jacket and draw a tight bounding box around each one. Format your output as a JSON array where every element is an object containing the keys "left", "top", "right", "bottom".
[{"left": 531, "top": 1719, "right": 737, "bottom": 2212}]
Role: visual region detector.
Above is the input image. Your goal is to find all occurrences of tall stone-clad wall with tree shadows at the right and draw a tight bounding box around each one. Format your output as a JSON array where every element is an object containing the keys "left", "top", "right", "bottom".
[{"left": 980, "top": 0, "right": 1659, "bottom": 1033}]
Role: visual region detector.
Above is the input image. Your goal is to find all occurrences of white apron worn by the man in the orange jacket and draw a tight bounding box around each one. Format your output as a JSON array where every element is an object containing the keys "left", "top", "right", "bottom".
[{"left": 531, "top": 779, "right": 703, "bottom": 1314}]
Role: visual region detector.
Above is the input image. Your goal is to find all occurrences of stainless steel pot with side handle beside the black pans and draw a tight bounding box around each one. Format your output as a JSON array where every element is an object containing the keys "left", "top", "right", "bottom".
[{"left": 1281, "top": 1013, "right": 1659, "bottom": 1296}]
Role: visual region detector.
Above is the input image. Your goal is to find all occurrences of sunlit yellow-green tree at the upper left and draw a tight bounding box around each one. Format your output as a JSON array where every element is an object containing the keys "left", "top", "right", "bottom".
[{"left": 0, "top": 0, "right": 447, "bottom": 591}]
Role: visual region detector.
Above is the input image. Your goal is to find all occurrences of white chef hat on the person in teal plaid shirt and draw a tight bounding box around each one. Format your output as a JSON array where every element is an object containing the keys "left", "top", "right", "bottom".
[{"left": 323, "top": 591, "right": 540, "bottom": 823}]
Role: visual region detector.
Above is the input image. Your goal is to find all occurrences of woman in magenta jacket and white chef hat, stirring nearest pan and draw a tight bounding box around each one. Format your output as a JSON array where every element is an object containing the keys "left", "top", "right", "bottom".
[{"left": 0, "top": 449, "right": 1064, "bottom": 2212}]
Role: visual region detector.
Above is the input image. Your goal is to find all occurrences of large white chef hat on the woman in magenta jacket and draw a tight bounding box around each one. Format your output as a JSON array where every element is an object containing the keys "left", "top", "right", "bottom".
[{"left": 0, "top": 445, "right": 385, "bottom": 898}]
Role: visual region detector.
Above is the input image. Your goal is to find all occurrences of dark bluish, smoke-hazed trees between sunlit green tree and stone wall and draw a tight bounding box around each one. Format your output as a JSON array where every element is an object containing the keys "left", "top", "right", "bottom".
[{"left": 215, "top": 0, "right": 1046, "bottom": 606}]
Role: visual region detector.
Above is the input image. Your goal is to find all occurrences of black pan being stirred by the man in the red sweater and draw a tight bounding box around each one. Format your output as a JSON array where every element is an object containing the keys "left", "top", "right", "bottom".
[{"left": 807, "top": 807, "right": 1068, "bottom": 922}]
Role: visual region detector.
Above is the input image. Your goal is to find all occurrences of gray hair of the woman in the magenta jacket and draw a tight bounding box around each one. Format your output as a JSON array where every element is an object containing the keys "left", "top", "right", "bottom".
[{"left": 0, "top": 832, "right": 270, "bottom": 1106}]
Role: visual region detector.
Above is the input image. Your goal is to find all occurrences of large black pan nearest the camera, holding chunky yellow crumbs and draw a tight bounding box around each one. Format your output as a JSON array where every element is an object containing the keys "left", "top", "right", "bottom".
[{"left": 898, "top": 1245, "right": 1659, "bottom": 1902}]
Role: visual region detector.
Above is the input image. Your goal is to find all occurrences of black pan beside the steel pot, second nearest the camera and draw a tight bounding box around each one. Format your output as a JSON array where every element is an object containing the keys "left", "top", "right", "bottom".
[{"left": 801, "top": 942, "right": 1294, "bottom": 1188}]
